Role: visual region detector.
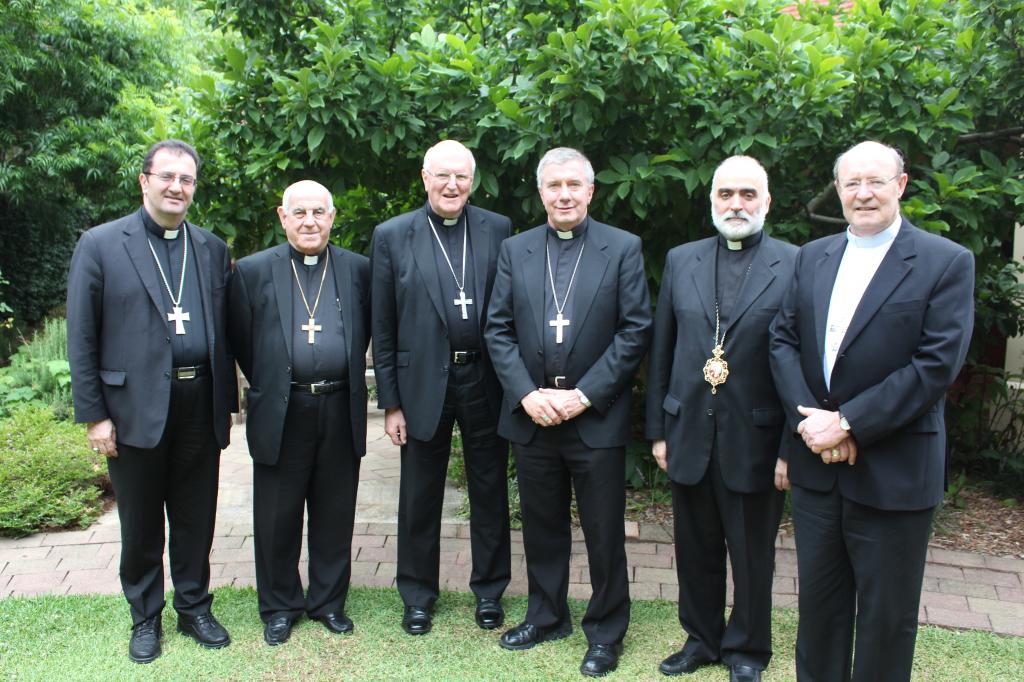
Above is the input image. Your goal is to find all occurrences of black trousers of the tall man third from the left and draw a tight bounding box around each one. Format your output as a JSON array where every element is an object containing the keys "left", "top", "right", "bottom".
[{"left": 395, "top": 363, "right": 512, "bottom": 608}]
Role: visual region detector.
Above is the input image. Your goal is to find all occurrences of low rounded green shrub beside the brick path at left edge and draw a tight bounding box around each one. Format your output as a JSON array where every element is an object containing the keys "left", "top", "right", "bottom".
[{"left": 0, "top": 406, "right": 106, "bottom": 537}]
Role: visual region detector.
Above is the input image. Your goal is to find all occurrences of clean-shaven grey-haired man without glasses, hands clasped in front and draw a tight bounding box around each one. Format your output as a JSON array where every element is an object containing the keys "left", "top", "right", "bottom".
[{"left": 484, "top": 147, "right": 651, "bottom": 676}]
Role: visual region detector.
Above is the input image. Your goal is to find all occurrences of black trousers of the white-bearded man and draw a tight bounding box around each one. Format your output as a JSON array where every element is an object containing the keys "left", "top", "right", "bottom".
[{"left": 672, "top": 447, "right": 782, "bottom": 670}]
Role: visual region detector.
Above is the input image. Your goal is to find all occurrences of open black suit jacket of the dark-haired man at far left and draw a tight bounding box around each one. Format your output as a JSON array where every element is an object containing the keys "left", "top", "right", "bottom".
[{"left": 68, "top": 209, "right": 238, "bottom": 447}]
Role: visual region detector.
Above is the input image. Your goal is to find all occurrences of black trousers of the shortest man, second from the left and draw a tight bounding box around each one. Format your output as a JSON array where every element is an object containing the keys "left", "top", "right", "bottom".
[{"left": 253, "top": 390, "right": 359, "bottom": 623}]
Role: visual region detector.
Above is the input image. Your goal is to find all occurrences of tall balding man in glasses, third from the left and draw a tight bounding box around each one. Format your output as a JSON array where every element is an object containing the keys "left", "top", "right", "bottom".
[{"left": 371, "top": 140, "right": 512, "bottom": 635}]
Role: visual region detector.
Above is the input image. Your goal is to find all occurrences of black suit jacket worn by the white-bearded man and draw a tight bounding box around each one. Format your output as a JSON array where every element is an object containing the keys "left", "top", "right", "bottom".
[{"left": 647, "top": 236, "right": 797, "bottom": 493}]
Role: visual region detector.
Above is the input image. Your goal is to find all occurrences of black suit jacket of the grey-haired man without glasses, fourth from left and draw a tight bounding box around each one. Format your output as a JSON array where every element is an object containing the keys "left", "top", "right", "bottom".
[{"left": 484, "top": 218, "right": 651, "bottom": 449}]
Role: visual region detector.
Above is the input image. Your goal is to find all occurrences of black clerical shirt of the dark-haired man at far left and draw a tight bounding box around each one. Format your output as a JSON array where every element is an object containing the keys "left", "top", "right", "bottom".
[{"left": 139, "top": 208, "right": 210, "bottom": 367}]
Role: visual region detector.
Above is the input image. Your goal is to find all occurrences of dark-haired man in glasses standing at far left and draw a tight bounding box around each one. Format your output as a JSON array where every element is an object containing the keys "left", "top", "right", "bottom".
[{"left": 68, "top": 139, "right": 238, "bottom": 663}]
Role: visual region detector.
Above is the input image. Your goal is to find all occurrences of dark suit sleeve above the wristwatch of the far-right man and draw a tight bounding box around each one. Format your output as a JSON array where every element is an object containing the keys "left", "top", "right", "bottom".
[{"left": 840, "top": 250, "right": 974, "bottom": 445}]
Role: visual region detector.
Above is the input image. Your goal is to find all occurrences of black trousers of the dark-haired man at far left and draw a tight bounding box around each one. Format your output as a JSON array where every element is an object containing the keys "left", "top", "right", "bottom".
[{"left": 106, "top": 376, "right": 220, "bottom": 625}]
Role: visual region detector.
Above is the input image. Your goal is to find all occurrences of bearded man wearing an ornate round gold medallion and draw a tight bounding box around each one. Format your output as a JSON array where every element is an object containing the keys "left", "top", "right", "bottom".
[{"left": 647, "top": 157, "right": 797, "bottom": 682}]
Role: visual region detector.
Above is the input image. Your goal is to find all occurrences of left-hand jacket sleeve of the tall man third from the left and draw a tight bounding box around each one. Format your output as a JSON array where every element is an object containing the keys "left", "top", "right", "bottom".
[{"left": 370, "top": 227, "right": 401, "bottom": 410}]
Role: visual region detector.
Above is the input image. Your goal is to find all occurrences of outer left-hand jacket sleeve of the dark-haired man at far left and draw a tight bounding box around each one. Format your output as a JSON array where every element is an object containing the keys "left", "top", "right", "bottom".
[{"left": 68, "top": 232, "right": 110, "bottom": 422}]
